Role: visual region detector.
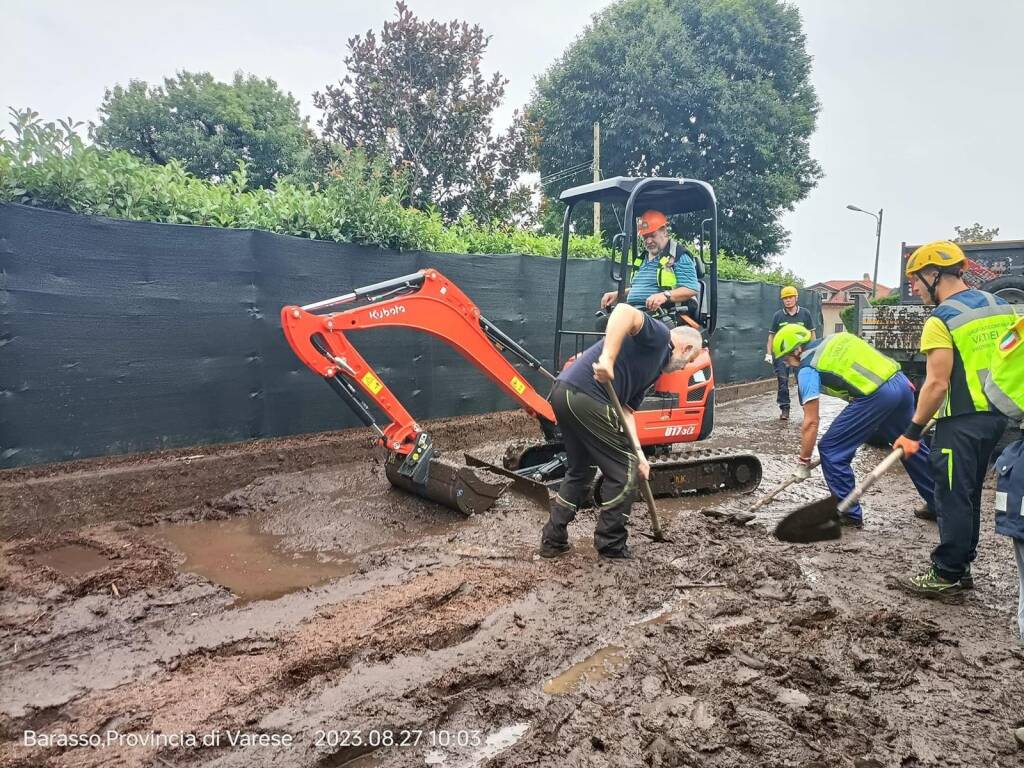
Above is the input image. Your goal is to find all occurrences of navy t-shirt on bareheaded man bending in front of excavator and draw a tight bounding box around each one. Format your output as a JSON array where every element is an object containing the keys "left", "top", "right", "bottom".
[{"left": 558, "top": 314, "right": 672, "bottom": 411}]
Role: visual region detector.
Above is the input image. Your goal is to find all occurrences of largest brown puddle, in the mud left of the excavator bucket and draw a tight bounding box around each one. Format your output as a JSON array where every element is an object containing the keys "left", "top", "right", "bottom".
[{"left": 151, "top": 517, "right": 355, "bottom": 604}]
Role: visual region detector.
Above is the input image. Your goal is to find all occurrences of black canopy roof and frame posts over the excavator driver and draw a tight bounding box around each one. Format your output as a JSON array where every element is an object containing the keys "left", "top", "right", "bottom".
[{"left": 552, "top": 176, "right": 718, "bottom": 371}]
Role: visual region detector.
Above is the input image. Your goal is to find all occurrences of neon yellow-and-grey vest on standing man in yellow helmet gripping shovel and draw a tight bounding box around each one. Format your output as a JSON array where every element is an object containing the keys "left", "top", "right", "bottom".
[{"left": 933, "top": 291, "right": 1014, "bottom": 419}]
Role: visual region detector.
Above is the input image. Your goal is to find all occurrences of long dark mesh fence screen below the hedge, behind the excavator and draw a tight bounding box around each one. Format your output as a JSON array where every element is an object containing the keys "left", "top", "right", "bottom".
[{"left": 0, "top": 205, "right": 819, "bottom": 468}]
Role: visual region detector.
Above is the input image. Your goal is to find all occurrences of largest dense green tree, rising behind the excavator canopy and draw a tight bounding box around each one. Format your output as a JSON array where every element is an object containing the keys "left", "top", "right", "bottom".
[{"left": 528, "top": 0, "right": 821, "bottom": 261}]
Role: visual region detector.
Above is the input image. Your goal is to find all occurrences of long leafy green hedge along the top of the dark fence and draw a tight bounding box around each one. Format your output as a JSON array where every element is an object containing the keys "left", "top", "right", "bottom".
[{"left": 0, "top": 110, "right": 803, "bottom": 285}]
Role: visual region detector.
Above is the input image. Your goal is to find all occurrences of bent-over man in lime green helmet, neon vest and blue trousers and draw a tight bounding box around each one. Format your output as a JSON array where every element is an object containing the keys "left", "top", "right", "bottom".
[{"left": 772, "top": 325, "right": 935, "bottom": 528}]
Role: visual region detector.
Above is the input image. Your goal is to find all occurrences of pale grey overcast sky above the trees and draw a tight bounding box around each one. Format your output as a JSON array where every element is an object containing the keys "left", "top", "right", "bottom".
[{"left": 0, "top": 0, "right": 1024, "bottom": 286}]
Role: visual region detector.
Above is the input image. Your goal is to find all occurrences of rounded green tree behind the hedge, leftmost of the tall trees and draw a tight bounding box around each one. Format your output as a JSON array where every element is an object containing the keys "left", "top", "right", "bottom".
[{"left": 92, "top": 72, "right": 309, "bottom": 186}]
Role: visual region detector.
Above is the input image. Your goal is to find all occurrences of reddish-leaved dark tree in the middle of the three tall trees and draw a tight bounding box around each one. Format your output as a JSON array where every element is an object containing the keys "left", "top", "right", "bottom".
[{"left": 313, "top": 2, "right": 534, "bottom": 221}]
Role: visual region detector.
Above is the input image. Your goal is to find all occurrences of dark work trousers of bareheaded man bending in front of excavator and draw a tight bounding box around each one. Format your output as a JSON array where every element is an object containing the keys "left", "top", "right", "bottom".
[{"left": 542, "top": 381, "right": 638, "bottom": 554}]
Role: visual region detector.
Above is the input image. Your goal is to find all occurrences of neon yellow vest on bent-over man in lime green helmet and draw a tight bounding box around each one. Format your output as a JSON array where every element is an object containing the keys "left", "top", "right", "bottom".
[{"left": 800, "top": 333, "right": 899, "bottom": 400}]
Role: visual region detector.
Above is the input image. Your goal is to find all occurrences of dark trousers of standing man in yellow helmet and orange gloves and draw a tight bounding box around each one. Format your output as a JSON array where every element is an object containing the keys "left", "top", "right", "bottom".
[{"left": 928, "top": 413, "right": 1007, "bottom": 582}]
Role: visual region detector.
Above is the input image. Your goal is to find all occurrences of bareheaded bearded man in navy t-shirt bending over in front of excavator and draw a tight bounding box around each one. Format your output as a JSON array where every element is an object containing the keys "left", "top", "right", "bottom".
[{"left": 541, "top": 304, "right": 702, "bottom": 559}]
